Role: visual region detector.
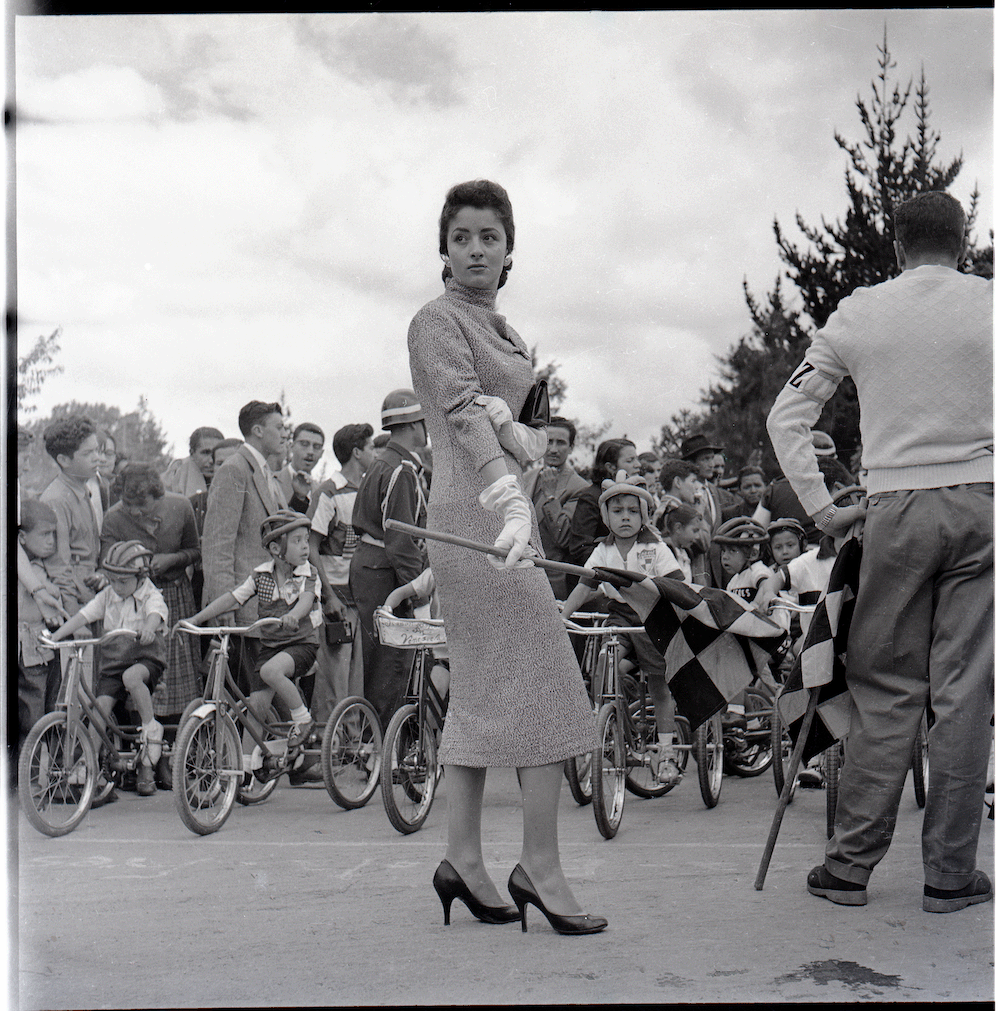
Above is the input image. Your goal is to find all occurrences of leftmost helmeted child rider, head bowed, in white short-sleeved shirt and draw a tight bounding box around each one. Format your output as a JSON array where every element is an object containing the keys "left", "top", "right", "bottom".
[{"left": 51, "top": 541, "right": 168, "bottom": 797}]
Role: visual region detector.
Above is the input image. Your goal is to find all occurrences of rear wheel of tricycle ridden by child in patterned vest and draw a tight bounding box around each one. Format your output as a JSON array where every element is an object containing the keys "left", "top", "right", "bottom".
[{"left": 320, "top": 696, "right": 382, "bottom": 810}]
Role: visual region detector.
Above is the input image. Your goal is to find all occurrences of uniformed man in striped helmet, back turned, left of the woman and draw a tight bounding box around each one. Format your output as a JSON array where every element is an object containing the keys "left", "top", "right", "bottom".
[{"left": 349, "top": 389, "right": 428, "bottom": 730}]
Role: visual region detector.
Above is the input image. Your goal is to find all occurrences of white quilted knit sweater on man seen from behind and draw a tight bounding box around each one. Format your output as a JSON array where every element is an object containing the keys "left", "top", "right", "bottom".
[{"left": 767, "top": 265, "right": 993, "bottom": 515}]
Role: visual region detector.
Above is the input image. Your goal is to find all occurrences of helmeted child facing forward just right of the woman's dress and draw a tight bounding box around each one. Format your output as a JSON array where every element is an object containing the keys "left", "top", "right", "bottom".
[{"left": 562, "top": 470, "right": 684, "bottom": 786}]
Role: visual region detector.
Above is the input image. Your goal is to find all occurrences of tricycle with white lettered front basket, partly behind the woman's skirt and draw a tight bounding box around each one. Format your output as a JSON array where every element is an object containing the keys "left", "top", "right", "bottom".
[{"left": 375, "top": 608, "right": 448, "bottom": 835}]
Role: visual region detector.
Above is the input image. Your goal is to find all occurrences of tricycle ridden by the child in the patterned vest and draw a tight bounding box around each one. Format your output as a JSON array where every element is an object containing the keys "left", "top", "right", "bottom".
[{"left": 174, "top": 618, "right": 382, "bottom": 835}]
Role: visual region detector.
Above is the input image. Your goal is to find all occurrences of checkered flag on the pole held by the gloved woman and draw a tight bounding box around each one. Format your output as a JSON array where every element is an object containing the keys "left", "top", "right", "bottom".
[{"left": 596, "top": 568, "right": 785, "bottom": 731}]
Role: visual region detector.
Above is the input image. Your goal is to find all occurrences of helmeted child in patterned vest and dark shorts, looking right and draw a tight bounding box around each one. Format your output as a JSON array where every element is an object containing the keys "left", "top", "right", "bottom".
[{"left": 180, "top": 510, "right": 323, "bottom": 773}]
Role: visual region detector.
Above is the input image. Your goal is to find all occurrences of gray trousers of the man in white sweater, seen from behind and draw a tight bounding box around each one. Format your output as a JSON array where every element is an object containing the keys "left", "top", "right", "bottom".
[{"left": 826, "top": 484, "right": 994, "bottom": 889}]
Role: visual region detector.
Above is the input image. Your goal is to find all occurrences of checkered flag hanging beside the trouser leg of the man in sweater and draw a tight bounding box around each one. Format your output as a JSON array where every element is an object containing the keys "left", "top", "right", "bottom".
[{"left": 778, "top": 537, "right": 861, "bottom": 761}]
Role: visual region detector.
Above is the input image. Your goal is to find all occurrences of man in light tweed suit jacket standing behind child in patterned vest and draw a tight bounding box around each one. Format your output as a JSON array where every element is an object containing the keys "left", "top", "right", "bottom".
[{"left": 201, "top": 400, "right": 288, "bottom": 687}]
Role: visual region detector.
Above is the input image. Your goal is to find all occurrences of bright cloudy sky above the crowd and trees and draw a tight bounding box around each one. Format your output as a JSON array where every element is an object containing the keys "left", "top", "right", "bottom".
[{"left": 14, "top": 9, "right": 993, "bottom": 469}]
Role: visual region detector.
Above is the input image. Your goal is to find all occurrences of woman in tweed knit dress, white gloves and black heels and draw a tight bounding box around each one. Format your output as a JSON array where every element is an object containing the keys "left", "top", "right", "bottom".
[{"left": 408, "top": 181, "right": 607, "bottom": 933}]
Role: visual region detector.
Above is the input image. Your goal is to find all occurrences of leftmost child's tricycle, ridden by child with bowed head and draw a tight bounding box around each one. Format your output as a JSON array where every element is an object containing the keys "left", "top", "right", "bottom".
[{"left": 17, "top": 629, "right": 170, "bottom": 836}]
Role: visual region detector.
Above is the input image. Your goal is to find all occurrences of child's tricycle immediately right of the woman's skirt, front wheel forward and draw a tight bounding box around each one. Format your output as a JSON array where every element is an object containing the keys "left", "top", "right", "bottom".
[{"left": 565, "top": 620, "right": 695, "bottom": 839}]
